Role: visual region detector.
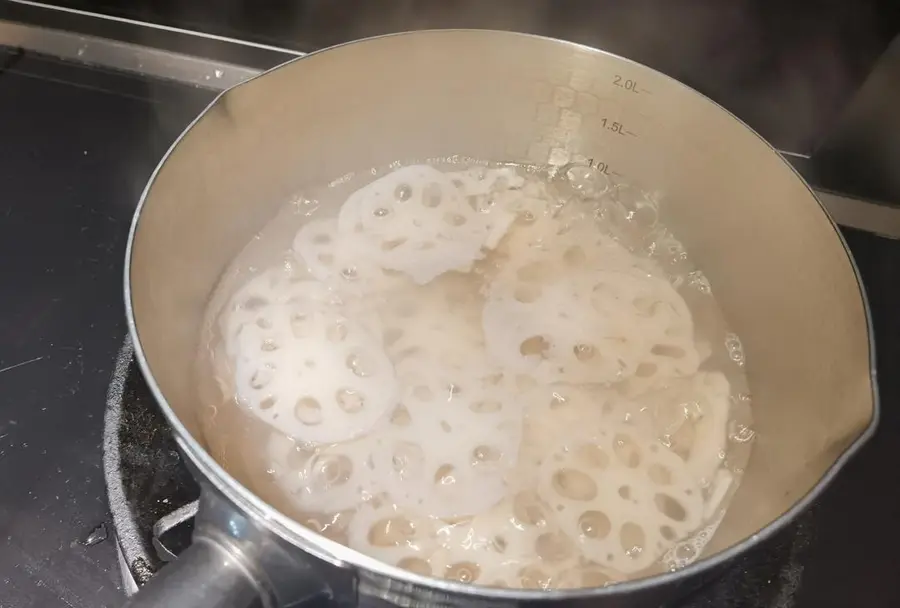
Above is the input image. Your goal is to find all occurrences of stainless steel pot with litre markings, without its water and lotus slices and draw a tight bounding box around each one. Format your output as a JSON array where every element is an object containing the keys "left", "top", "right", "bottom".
[{"left": 125, "top": 31, "right": 878, "bottom": 608}]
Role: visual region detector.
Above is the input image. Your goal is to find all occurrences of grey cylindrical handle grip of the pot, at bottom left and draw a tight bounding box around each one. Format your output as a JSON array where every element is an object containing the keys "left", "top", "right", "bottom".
[{"left": 124, "top": 537, "right": 267, "bottom": 608}]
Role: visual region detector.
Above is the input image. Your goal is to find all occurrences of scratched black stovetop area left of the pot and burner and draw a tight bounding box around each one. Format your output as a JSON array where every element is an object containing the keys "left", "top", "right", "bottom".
[{"left": 0, "top": 47, "right": 211, "bottom": 608}]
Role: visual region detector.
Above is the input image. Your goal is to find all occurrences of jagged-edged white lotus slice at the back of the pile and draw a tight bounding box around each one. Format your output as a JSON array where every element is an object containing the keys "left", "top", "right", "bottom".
[{"left": 338, "top": 165, "right": 511, "bottom": 284}]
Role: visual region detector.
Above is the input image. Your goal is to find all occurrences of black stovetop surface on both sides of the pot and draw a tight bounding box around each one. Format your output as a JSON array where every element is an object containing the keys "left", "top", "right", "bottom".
[{"left": 0, "top": 39, "right": 900, "bottom": 608}]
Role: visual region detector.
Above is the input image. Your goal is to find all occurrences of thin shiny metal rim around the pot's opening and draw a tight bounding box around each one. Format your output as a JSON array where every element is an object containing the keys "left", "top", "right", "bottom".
[{"left": 124, "top": 28, "right": 881, "bottom": 602}]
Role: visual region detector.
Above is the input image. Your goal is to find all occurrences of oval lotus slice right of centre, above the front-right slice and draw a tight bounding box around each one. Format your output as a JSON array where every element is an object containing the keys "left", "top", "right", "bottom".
[{"left": 483, "top": 261, "right": 699, "bottom": 383}]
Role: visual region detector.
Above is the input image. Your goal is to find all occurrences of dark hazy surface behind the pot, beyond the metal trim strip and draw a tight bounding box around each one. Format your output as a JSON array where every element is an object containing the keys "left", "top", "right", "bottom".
[{"left": 139, "top": 0, "right": 890, "bottom": 153}]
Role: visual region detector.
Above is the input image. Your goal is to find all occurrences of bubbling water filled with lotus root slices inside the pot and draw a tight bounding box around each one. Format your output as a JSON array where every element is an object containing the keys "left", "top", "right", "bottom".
[{"left": 198, "top": 163, "right": 752, "bottom": 588}]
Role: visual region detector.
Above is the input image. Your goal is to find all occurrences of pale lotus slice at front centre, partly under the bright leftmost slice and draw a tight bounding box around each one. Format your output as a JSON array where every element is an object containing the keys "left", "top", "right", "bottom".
[{"left": 374, "top": 358, "right": 522, "bottom": 517}]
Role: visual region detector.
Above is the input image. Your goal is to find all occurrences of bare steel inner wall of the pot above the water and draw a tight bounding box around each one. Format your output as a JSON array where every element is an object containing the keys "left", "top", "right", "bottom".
[{"left": 130, "top": 31, "right": 874, "bottom": 564}]
